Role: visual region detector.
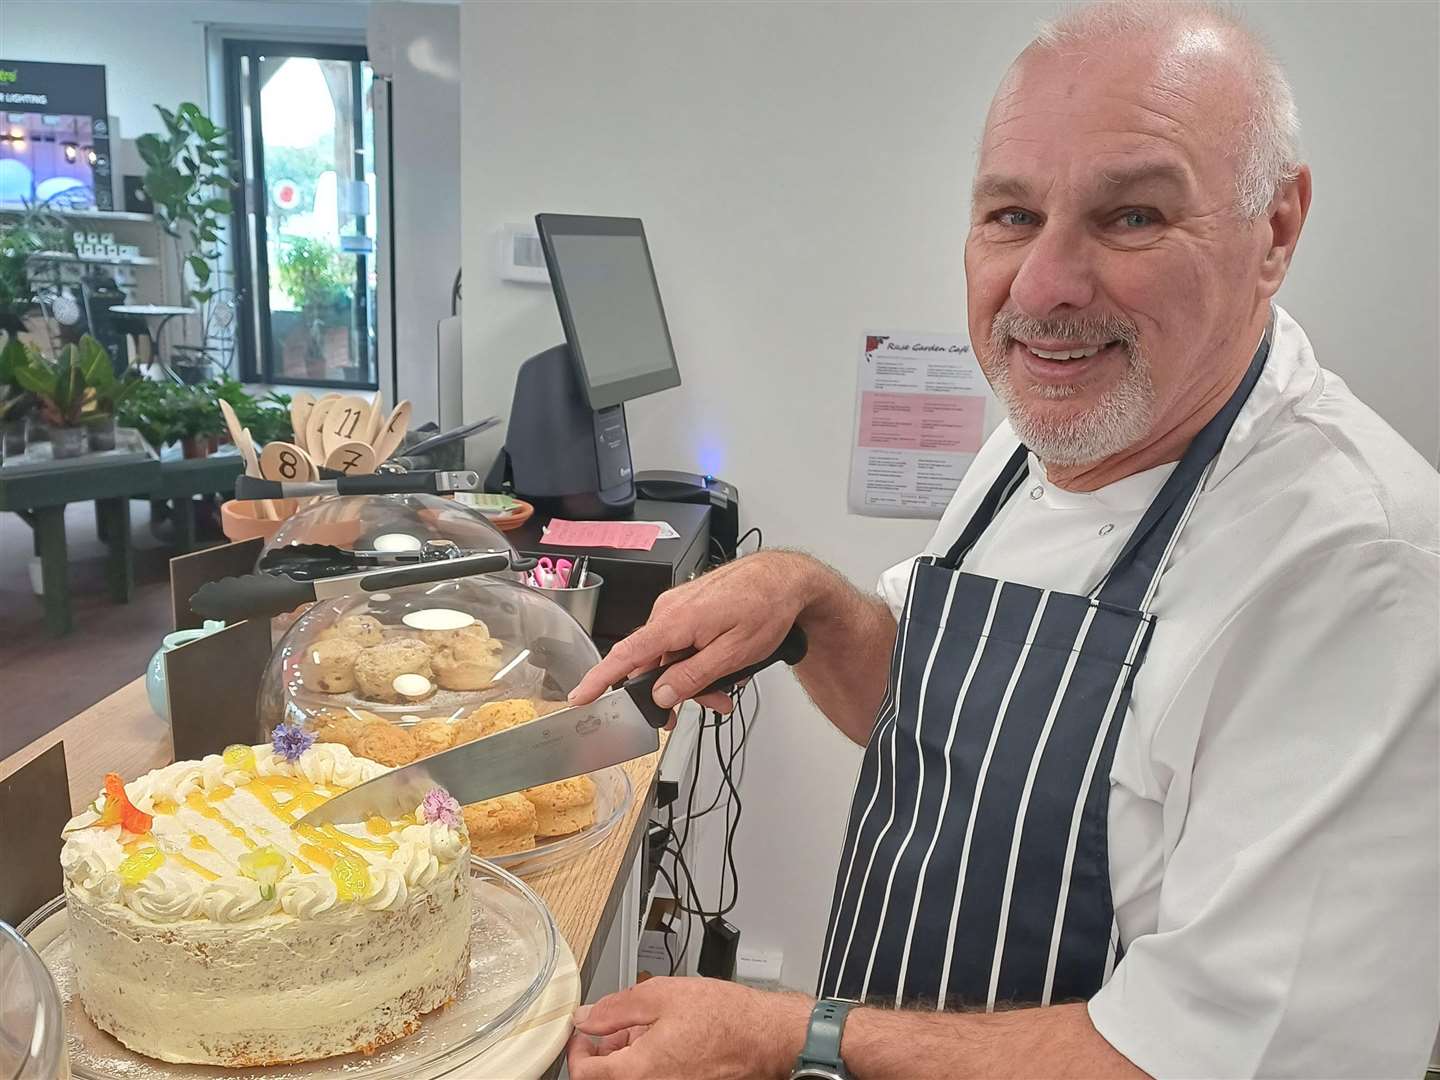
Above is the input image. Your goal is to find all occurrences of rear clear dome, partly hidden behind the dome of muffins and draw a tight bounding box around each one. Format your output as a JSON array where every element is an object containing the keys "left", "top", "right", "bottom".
[{"left": 261, "top": 494, "right": 514, "bottom": 566}]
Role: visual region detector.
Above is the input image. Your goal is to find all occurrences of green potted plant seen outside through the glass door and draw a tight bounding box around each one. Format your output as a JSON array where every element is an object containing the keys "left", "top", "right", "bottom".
[{"left": 278, "top": 236, "right": 353, "bottom": 379}]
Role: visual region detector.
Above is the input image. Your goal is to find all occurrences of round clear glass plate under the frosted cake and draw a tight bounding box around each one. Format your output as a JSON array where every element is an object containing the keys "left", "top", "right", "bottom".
[{"left": 17, "top": 860, "right": 557, "bottom": 1080}]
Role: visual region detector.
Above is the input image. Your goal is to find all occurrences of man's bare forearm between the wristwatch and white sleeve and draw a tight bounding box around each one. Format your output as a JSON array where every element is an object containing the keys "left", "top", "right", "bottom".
[{"left": 841, "top": 1004, "right": 1146, "bottom": 1080}]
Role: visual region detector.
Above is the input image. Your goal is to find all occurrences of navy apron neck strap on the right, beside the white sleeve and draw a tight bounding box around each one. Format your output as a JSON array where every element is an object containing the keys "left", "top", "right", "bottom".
[{"left": 1090, "top": 311, "right": 1274, "bottom": 611}]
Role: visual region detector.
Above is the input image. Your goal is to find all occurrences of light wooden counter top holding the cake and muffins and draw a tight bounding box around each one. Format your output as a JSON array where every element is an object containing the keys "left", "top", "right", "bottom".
[{"left": 0, "top": 678, "right": 667, "bottom": 994}]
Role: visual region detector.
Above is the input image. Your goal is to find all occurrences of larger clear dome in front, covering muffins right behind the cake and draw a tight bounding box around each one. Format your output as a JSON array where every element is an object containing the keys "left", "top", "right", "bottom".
[{"left": 259, "top": 575, "right": 600, "bottom": 743}]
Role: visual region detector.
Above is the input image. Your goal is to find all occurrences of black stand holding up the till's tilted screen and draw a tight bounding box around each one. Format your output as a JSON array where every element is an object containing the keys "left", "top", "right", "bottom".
[{"left": 487, "top": 346, "right": 635, "bottom": 520}]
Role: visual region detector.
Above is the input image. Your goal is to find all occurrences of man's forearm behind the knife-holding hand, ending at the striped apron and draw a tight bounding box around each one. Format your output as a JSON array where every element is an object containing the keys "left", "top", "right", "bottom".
[{"left": 795, "top": 556, "right": 896, "bottom": 744}]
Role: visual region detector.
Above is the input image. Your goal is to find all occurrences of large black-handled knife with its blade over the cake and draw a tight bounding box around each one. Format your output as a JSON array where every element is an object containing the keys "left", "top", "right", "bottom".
[{"left": 295, "top": 626, "right": 806, "bottom": 827}]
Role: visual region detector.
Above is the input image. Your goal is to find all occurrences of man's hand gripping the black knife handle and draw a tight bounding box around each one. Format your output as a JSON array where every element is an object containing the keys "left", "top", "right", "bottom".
[{"left": 570, "top": 552, "right": 822, "bottom": 713}]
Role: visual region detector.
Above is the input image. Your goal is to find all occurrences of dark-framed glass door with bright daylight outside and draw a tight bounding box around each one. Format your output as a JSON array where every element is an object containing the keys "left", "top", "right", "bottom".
[{"left": 225, "top": 40, "right": 377, "bottom": 389}]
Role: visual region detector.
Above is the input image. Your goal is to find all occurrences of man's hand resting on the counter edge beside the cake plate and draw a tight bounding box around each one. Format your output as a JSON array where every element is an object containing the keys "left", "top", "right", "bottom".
[{"left": 569, "top": 979, "right": 814, "bottom": 1080}]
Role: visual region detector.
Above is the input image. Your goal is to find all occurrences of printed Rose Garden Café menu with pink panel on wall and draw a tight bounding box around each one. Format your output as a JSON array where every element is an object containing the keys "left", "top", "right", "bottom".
[{"left": 850, "top": 331, "right": 991, "bottom": 517}]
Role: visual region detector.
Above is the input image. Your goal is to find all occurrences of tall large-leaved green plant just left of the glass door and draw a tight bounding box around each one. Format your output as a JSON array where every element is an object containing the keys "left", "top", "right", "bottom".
[{"left": 135, "top": 101, "right": 238, "bottom": 377}]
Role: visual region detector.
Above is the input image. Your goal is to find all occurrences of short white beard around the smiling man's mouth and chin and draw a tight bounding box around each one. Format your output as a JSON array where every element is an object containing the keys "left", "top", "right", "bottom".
[{"left": 991, "top": 350, "right": 1155, "bottom": 467}]
